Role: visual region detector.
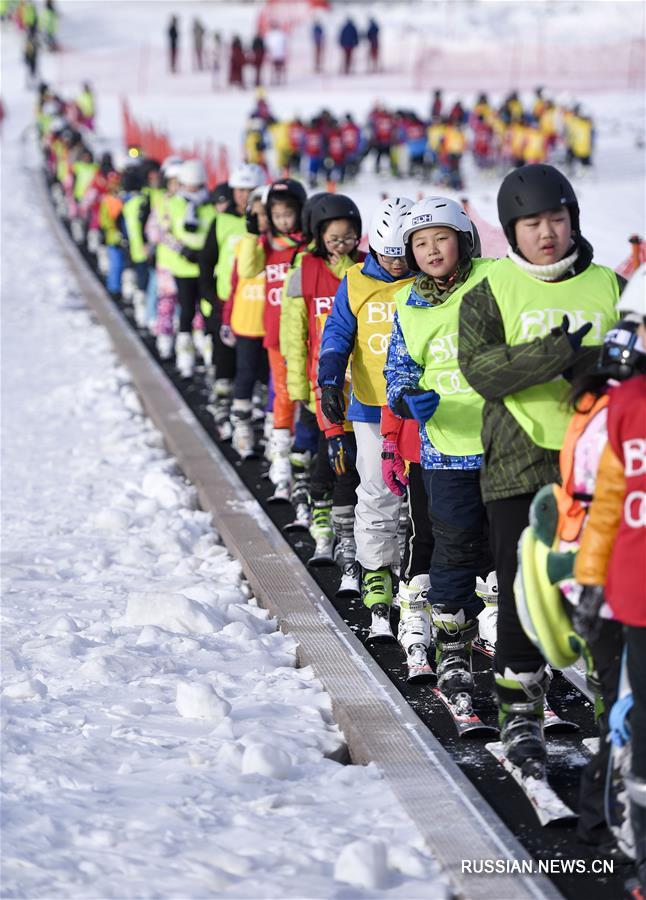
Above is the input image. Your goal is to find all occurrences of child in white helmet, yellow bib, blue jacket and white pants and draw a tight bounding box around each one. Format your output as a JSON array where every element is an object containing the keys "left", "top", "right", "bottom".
[{"left": 318, "top": 197, "right": 413, "bottom": 620}]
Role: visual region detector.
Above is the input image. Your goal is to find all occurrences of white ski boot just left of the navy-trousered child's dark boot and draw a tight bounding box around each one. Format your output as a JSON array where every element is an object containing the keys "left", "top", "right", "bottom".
[{"left": 397, "top": 575, "right": 434, "bottom": 682}]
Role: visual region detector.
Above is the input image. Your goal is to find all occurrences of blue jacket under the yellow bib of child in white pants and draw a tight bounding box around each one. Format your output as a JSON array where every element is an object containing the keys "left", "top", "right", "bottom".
[{"left": 318, "top": 254, "right": 412, "bottom": 423}]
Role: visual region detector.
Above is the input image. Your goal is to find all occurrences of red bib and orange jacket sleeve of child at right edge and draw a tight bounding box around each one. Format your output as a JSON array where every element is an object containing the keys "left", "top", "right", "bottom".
[{"left": 574, "top": 375, "right": 646, "bottom": 628}]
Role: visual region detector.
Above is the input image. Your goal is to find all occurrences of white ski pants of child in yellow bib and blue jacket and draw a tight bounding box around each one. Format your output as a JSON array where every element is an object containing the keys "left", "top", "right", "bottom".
[{"left": 352, "top": 422, "right": 401, "bottom": 571}]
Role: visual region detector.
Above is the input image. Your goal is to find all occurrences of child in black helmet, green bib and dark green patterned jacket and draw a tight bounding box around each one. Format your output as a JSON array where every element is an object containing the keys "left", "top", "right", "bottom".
[{"left": 458, "top": 165, "right": 620, "bottom": 774}]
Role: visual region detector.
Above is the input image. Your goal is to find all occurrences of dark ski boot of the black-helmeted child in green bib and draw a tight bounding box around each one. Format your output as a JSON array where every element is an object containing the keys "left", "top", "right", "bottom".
[{"left": 494, "top": 666, "right": 551, "bottom": 778}]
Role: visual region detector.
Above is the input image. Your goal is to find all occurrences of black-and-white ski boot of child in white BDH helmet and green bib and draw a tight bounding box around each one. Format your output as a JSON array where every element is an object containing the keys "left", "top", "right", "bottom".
[{"left": 432, "top": 603, "right": 478, "bottom": 715}]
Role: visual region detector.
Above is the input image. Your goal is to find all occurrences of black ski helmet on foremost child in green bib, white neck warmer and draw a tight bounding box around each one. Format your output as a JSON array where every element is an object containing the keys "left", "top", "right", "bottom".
[{"left": 498, "top": 163, "right": 579, "bottom": 248}]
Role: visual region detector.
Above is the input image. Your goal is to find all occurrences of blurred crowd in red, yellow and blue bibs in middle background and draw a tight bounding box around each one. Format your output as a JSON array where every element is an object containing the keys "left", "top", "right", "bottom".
[{"left": 244, "top": 87, "right": 594, "bottom": 190}]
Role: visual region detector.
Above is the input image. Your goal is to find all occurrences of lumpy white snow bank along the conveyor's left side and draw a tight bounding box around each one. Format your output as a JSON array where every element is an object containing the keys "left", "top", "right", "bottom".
[{"left": 1, "top": 15, "right": 447, "bottom": 898}]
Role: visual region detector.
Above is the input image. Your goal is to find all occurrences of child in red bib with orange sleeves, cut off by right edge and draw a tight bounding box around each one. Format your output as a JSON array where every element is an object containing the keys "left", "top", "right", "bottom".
[{"left": 575, "top": 320, "right": 646, "bottom": 897}]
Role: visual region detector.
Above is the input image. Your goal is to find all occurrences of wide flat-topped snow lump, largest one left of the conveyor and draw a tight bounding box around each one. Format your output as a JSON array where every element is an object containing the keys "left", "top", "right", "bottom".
[{"left": 118, "top": 593, "right": 224, "bottom": 634}]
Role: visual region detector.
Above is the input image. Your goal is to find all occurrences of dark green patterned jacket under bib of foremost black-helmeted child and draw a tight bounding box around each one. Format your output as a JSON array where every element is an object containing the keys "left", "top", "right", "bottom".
[{"left": 458, "top": 239, "right": 625, "bottom": 502}]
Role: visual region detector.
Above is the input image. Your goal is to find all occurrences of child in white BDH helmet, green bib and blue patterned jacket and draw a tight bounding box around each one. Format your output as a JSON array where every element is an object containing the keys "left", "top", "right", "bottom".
[{"left": 385, "top": 197, "right": 492, "bottom": 714}]
